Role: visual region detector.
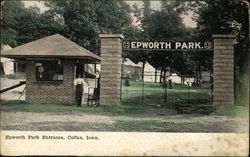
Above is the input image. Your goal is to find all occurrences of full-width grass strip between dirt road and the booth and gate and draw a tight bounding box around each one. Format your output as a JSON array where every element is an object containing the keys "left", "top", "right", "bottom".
[{"left": 0, "top": 100, "right": 249, "bottom": 117}]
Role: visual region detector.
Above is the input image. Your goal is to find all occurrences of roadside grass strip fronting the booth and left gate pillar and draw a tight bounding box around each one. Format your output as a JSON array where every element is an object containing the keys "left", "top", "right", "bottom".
[{"left": 1, "top": 101, "right": 176, "bottom": 116}]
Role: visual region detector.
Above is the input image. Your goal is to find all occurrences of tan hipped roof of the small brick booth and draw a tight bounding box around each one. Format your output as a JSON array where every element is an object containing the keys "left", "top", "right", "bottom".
[{"left": 1, "top": 34, "right": 101, "bottom": 62}]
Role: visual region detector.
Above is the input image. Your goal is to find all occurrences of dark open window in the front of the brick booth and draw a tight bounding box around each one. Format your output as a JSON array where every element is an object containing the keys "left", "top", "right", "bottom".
[{"left": 36, "top": 60, "right": 63, "bottom": 82}]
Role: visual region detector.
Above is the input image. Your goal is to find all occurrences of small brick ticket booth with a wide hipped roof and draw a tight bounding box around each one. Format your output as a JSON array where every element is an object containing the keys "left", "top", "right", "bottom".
[{"left": 1, "top": 34, "right": 101, "bottom": 104}]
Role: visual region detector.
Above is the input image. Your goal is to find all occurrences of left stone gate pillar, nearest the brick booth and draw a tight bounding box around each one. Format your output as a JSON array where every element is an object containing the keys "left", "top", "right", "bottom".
[{"left": 99, "top": 34, "right": 123, "bottom": 105}]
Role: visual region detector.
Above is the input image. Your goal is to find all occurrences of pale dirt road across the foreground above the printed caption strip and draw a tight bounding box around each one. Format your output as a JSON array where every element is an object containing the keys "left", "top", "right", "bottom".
[{"left": 1, "top": 112, "right": 248, "bottom": 132}]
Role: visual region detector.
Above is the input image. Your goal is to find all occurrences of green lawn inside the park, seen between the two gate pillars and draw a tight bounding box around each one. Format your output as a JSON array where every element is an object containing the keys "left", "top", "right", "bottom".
[{"left": 122, "top": 81, "right": 212, "bottom": 113}]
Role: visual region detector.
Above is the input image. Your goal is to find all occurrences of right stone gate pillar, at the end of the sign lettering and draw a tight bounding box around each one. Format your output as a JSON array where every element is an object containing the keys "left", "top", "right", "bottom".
[{"left": 212, "top": 34, "right": 235, "bottom": 105}]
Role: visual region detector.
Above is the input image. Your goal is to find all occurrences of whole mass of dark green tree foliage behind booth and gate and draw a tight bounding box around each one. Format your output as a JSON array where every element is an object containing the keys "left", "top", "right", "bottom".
[{"left": 1, "top": 0, "right": 249, "bottom": 100}]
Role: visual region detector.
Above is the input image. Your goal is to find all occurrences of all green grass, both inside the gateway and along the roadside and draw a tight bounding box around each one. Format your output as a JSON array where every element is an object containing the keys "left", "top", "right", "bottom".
[{"left": 0, "top": 81, "right": 248, "bottom": 116}]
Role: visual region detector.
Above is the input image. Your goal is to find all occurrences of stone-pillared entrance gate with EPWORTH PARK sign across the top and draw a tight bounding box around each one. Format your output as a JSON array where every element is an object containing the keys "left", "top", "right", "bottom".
[{"left": 99, "top": 34, "right": 234, "bottom": 105}]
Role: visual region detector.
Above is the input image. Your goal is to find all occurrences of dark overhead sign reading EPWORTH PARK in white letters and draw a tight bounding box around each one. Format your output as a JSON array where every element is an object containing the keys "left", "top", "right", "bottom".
[{"left": 122, "top": 40, "right": 212, "bottom": 50}]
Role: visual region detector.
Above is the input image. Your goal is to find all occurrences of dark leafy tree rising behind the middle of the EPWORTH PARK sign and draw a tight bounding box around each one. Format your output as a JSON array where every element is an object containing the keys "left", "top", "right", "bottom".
[{"left": 146, "top": 1, "right": 190, "bottom": 81}]
